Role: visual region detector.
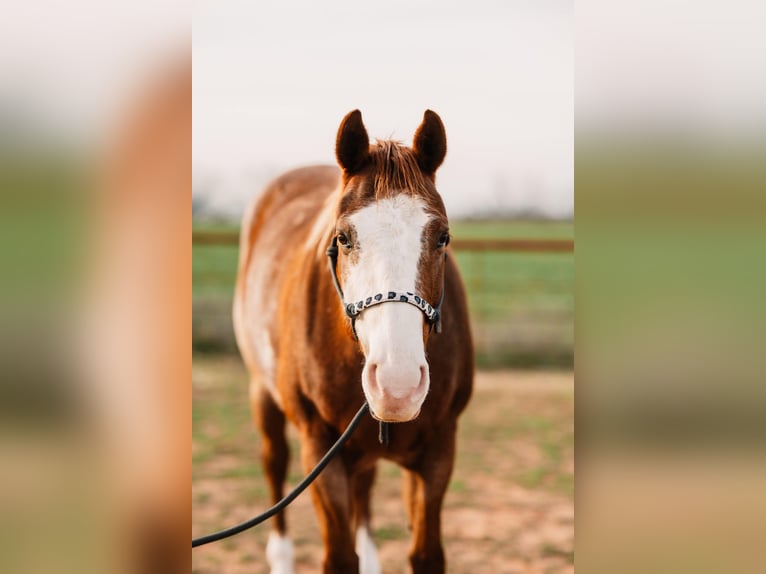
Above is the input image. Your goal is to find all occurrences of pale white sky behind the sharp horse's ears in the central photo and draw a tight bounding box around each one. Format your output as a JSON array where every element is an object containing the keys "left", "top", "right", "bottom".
[{"left": 193, "top": 0, "right": 574, "bottom": 218}]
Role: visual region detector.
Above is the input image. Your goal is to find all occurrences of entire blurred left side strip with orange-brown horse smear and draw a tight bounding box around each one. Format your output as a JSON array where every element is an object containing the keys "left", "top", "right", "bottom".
[{"left": 0, "top": 0, "right": 191, "bottom": 574}]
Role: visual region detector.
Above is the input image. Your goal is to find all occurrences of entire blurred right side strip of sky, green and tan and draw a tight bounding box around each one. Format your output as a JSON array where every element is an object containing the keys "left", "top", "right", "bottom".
[{"left": 575, "top": 0, "right": 766, "bottom": 573}]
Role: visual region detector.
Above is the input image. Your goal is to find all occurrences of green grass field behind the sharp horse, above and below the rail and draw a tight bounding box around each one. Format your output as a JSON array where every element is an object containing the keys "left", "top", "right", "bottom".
[{"left": 192, "top": 221, "right": 574, "bottom": 367}]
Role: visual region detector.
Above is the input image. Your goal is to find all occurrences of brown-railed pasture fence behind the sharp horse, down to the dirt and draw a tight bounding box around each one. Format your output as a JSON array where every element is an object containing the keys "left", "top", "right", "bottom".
[{"left": 192, "top": 230, "right": 574, "bottom": 367}]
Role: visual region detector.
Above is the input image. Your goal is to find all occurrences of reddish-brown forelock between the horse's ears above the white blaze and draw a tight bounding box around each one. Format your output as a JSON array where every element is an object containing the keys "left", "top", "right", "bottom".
[{"left": 370, "top": 140, "right": 434, "bottom": 201}]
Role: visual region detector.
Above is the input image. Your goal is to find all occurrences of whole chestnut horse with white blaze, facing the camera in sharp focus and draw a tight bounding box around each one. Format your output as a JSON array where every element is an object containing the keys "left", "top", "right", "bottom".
[{"left": 233, "top": 110, "right": 474, "bottom": 574}]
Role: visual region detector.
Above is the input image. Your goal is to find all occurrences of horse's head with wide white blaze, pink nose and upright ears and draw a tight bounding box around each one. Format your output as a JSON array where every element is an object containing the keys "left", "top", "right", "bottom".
[{"left": 335, "top": 110, "right": 449, "bottom": 422}]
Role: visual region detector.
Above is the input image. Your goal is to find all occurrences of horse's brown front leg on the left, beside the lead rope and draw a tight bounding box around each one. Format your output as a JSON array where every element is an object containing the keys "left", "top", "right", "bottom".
[{"left": 301, "top": 423, "right": 359, "bottom": 574}]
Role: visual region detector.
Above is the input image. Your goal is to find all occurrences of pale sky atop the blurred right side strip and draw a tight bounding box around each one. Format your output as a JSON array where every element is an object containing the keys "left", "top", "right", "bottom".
[{"left": 575, "top": 0, "right": 766, "bottom": 136}]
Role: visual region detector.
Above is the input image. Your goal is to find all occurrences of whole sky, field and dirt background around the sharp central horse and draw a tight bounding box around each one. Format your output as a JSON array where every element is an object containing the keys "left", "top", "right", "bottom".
[{"left": 192, "top": 0, "right": 574, "bottom": 574}]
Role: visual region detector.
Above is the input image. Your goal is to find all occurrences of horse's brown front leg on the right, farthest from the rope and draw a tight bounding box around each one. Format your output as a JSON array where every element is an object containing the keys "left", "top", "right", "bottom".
[{"left": 409, "top": 424, "right": 455, "bottom": 574}]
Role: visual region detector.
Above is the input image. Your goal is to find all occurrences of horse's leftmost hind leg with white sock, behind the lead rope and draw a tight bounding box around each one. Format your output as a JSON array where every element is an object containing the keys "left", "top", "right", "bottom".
[{"left": 251, "top": 383, "right": 295, "bottom": 574}]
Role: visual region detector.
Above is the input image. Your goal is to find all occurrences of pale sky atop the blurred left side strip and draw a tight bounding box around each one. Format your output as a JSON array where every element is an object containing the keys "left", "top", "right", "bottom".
[{"left": 0, "top": 0, "right": 191, "bottom": 146}]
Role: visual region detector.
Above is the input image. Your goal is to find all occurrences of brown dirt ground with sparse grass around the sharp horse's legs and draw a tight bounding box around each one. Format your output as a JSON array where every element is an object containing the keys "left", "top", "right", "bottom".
[{"left": 192, "top": 359, "right": 574, "bottom": 574}]
